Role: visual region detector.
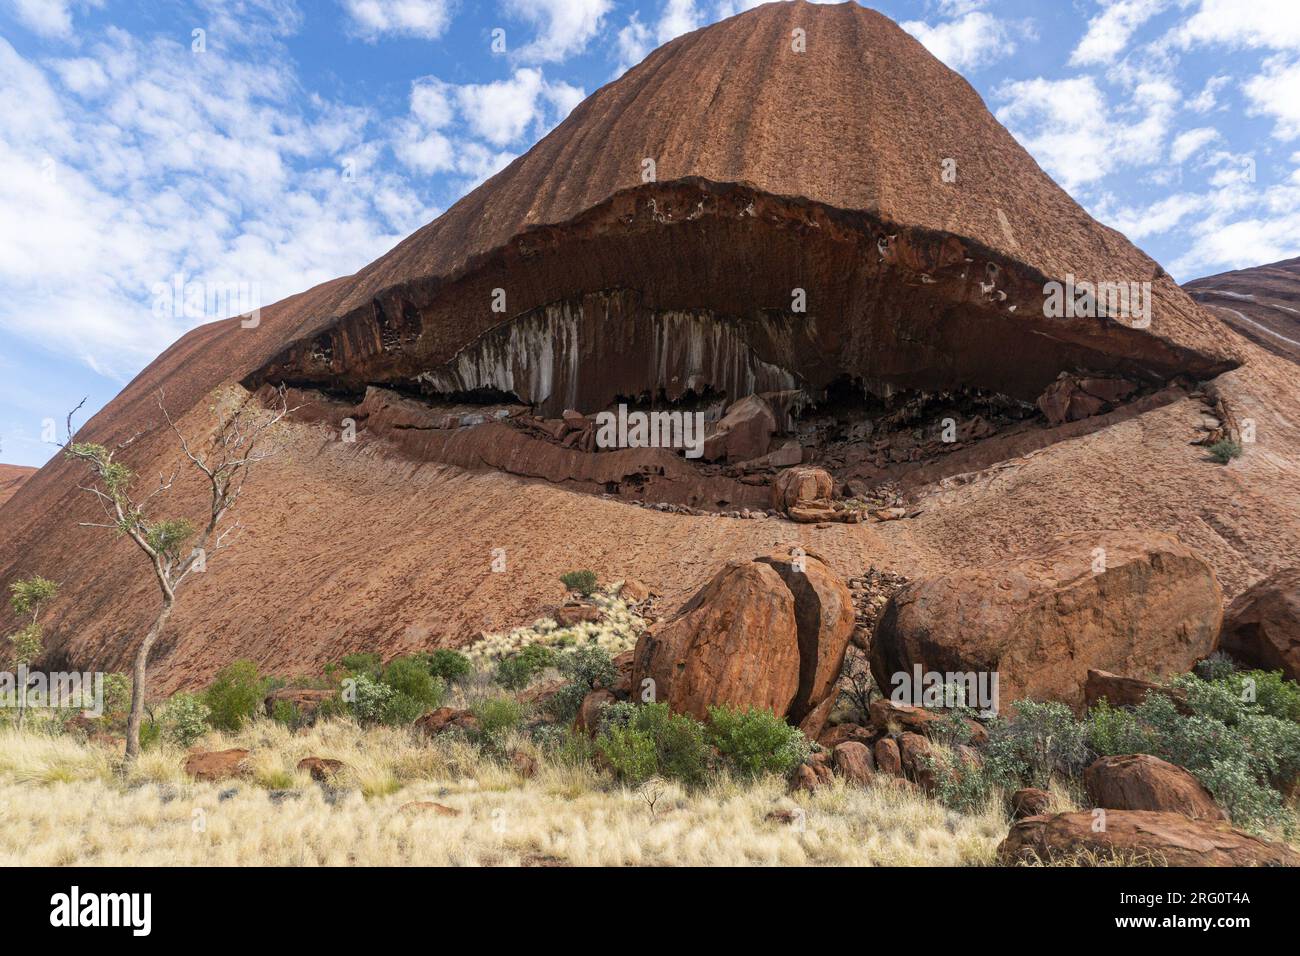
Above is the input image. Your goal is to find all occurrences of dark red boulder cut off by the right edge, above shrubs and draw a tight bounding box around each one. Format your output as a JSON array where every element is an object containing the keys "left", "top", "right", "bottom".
[{"left": 1219, "top": 564, "right": 1300, "bottom": 680}]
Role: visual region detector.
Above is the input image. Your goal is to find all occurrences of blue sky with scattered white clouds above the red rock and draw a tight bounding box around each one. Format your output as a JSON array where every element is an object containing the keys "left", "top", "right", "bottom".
[{"left": 0, "top": 0, "right": 1300, "bottom": 464}]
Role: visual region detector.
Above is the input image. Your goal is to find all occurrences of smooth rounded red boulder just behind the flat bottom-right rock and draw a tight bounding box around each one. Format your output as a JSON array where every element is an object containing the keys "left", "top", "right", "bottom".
[{"left": 1083, "top": 753, "right": 1227, "bottom": 821}]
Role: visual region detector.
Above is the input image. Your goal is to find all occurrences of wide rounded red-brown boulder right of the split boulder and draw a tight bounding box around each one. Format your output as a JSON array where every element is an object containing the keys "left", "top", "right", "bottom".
[{"left": 871, "top": 532, "right": 1223, "bottom": 710}]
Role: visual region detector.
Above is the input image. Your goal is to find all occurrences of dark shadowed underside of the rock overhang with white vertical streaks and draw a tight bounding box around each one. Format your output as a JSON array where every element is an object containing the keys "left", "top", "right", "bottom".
[{"left": 247, "top": 178, "right": 1236, "bottom": 415}]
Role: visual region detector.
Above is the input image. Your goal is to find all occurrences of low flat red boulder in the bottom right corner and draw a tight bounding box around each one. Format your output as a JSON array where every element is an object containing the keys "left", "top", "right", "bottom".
[{"left": 997, "top": 810, "right": 1300, "bottom": 866}]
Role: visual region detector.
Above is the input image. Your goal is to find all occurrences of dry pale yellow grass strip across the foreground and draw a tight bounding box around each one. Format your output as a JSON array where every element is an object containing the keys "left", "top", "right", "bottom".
[{"left": 0, "top": 722, "right": 1008, "bottom": 866}]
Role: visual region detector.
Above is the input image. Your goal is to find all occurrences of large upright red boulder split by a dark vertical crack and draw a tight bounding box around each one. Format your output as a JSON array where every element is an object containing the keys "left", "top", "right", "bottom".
[{"left": 632, "top": 549, "right": 854, "bottom": 723}]
